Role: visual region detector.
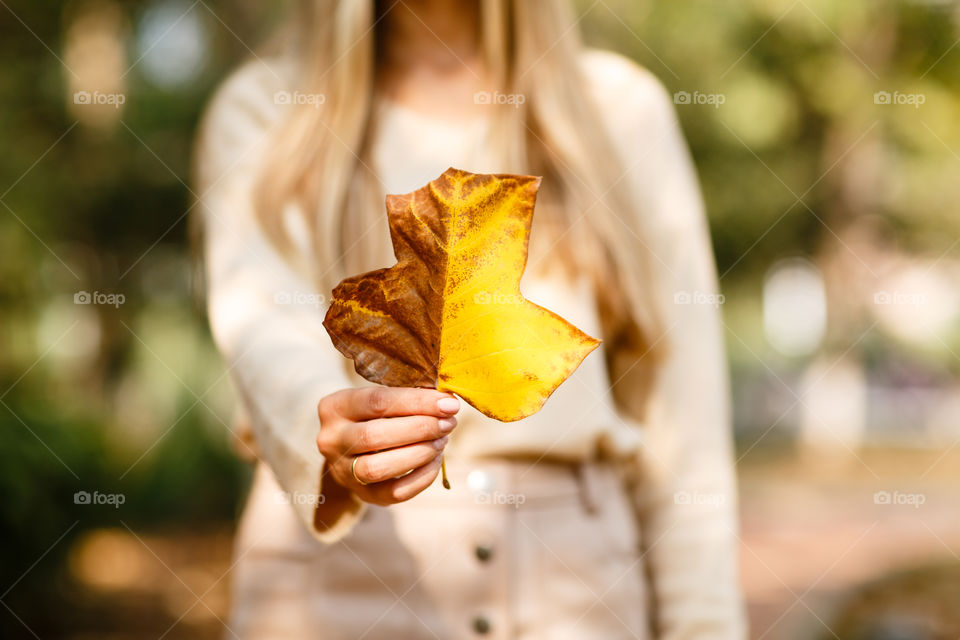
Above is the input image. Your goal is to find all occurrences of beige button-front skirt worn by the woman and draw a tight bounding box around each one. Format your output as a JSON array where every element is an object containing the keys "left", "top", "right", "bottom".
[{"left": 227, "top": 459, "right": 649, "bottom": 640}]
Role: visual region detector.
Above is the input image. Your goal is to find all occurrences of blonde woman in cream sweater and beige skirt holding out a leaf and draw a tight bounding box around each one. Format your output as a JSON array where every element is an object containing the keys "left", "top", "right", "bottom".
[{"left": 197, "top": 0, "right": 745, "bottom": 639}]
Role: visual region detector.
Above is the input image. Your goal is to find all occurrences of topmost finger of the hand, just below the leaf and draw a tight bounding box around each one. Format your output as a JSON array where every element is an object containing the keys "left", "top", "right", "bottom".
[{"left": 331, "top": 387, "right": 460, "bottom": 422}]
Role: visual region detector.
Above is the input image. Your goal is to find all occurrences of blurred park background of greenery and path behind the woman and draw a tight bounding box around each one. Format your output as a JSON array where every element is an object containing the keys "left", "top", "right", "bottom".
[{"left": 0, "top": 0, "right": 960, "bottom": 640}]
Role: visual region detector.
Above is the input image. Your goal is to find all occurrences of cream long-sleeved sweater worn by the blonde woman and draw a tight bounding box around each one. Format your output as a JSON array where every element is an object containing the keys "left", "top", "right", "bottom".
[{"left": 197, "top": 51, "right": 745, "bottom": 639}]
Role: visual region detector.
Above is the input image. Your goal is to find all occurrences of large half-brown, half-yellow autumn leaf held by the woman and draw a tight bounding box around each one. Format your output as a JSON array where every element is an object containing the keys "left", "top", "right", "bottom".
[{"left": 323, "top": 169, "right": 600, "bottom": 422}]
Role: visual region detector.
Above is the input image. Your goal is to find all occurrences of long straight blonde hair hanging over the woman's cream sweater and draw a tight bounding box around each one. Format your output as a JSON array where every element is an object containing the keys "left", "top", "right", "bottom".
[{"left": 255, "top": 0, "right": 665, "bottom": 400}]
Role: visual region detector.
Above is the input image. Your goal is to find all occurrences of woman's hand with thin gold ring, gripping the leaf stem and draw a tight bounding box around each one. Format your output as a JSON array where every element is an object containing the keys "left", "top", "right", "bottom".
[{"left": 317, "top": 387, "right": 460, "bottom": 505}]
